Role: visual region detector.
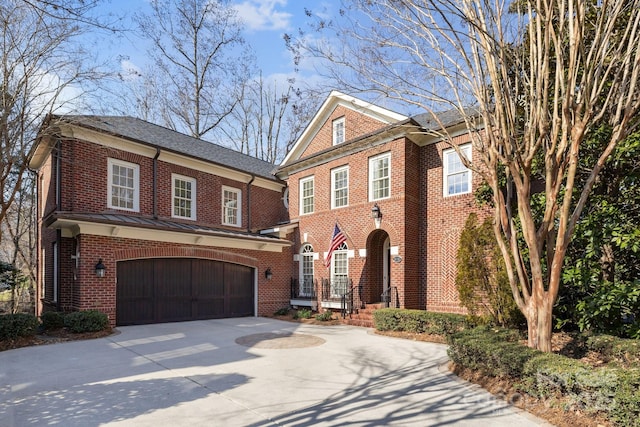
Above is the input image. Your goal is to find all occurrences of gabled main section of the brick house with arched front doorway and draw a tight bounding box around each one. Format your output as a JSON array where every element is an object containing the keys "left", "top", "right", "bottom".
[{"left": 277, "top": 92, "right": 480, "bottom": 318}]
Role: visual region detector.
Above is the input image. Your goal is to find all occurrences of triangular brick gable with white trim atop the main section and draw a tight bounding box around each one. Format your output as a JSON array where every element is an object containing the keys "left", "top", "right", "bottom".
[{"left": 280, "top": 91, "right": 408, "bottom": 167}]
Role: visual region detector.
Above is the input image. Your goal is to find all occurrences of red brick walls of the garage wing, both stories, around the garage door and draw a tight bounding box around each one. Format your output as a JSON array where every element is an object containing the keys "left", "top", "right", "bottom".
[{"left": 38, "top": 133, "right": 291, "bottom": 323}]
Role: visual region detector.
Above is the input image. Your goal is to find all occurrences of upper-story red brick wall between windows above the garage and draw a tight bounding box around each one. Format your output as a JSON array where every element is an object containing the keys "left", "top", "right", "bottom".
[{"left": 55, "top": 140, "right": 286, "bottom": 230}]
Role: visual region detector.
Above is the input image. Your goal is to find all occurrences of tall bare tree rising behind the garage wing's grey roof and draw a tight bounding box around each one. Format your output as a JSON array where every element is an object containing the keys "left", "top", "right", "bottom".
[{"left": 136, "top": 0, "right": 251, "bottom": 138}]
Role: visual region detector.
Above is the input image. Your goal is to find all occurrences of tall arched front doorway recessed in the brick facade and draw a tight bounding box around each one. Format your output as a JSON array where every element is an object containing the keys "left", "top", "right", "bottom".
[{"left": 363, "top": 230, "right": 391, "bottom": 303}]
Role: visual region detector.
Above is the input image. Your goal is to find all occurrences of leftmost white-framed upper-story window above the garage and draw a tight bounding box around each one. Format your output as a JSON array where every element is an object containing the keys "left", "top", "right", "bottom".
[{"left": 107, "top": 159, "right": 140, "bottom": 212}]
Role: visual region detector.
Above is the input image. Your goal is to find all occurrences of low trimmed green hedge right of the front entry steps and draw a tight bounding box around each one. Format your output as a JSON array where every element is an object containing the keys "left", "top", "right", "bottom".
[{"left": 373, "top": 308, "right": 474, "bottom": 335}]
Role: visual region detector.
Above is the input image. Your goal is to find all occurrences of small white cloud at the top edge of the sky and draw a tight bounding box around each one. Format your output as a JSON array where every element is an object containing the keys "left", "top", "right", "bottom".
[{"left": 233, "top": 0, "right": 292, "bottom": 31}]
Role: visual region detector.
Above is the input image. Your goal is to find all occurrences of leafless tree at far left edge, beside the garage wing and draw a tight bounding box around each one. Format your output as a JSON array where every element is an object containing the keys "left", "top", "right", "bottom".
[{"left": 0, "top": 0, "right": 101, "bottom": 308}]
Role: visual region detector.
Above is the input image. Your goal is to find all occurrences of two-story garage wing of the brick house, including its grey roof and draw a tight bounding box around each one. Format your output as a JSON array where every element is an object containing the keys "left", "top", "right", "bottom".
[{"left": 30, "top": 116, "right": 292, "bottom": 325}]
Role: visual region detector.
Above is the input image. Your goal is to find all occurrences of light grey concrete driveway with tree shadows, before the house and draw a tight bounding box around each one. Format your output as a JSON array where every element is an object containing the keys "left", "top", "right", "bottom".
[{"left": 0, "top": 318, "right": 548, "bottom": 427}]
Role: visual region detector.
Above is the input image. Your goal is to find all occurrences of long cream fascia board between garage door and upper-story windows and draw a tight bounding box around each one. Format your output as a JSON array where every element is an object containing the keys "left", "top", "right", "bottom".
[{"left": 50, "top": 219, "right": 291, "bottom": 252}]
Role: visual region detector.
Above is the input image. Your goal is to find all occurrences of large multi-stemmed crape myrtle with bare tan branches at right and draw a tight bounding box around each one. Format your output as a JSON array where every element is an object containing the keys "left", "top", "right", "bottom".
[{"left": 288, "top": 0, "right": 640, "bottom": 351}]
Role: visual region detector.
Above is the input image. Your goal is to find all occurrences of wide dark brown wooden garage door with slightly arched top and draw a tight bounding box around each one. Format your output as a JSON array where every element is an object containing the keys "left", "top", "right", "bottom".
[{"left": 116, "top": 258, "right": 254, "bottom": 325}]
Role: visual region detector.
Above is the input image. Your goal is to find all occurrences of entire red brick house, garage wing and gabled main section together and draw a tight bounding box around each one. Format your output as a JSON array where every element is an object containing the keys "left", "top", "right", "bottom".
[{"left": 30, "top": 92, "right": 479, "bottom": 325}]
